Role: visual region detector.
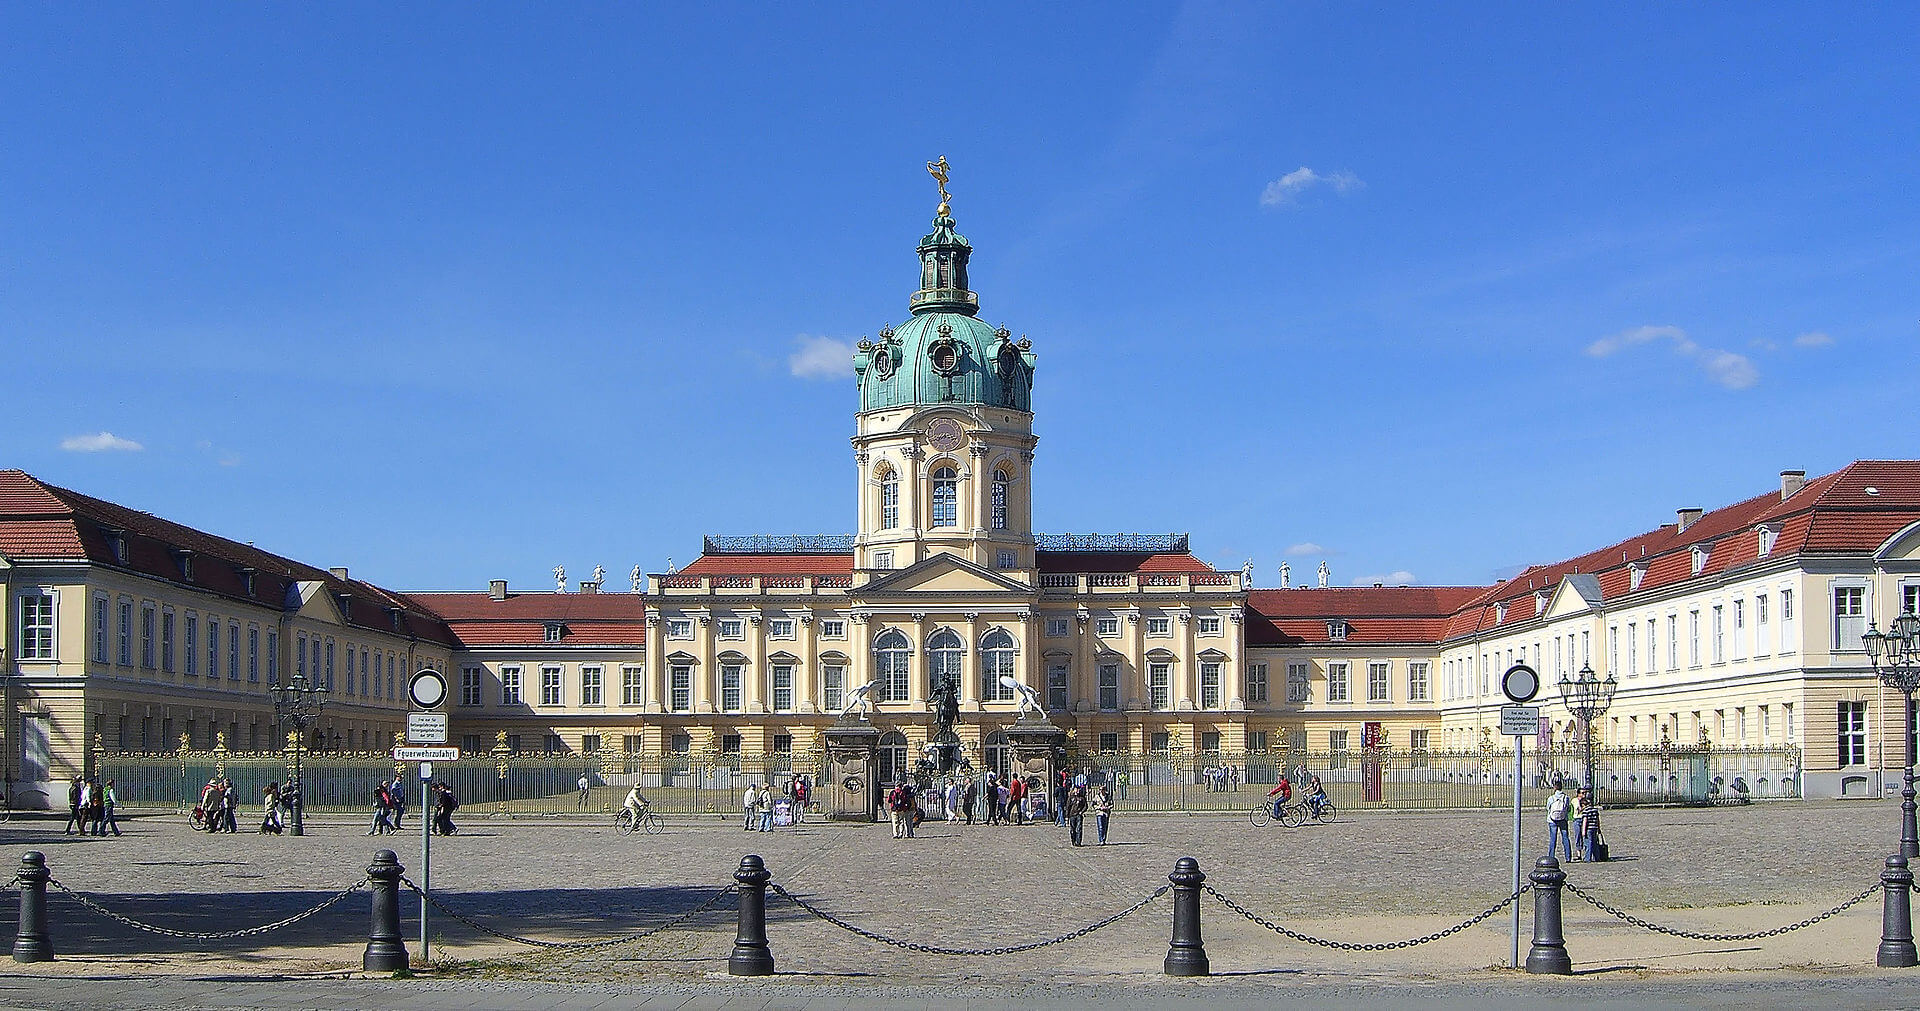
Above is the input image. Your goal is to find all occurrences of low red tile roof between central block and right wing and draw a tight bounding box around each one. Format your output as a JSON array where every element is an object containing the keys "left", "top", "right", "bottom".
[{"left": 1246, "top": 587, "right": 1486, "bottom": 647}]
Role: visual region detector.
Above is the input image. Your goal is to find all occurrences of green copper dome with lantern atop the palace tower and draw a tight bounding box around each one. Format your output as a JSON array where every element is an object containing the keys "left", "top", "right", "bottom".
[{"left": 852, "top": 203, "right": 1033, "bottom": 412}]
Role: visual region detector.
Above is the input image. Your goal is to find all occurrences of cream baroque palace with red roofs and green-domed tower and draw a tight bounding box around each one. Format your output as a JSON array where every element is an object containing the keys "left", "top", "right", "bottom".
[{"left": 0, "top": 176, "right": 1920, "bottom": 796}]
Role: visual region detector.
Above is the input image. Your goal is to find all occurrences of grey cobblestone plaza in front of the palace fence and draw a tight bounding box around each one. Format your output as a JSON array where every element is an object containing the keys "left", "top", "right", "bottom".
[{"left": 0, "top": 794, "right": 1920, "bottom": 1003}]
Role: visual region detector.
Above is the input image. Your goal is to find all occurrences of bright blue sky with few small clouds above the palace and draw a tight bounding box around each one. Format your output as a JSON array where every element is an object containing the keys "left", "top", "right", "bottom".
[{"left": 0, "top": 4, "right": 1920, "bottom": 589}]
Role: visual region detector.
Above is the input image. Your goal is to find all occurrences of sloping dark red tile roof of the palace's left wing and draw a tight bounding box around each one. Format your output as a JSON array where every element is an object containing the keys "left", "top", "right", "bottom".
[{"left": 0, "top": 470, "right": 453, "bottom": 645}]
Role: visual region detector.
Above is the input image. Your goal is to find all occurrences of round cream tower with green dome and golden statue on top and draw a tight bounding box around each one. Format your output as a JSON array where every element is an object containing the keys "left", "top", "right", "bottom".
[{"left": 852, "top": 157, "right": 1035, "bottom": 581}]
